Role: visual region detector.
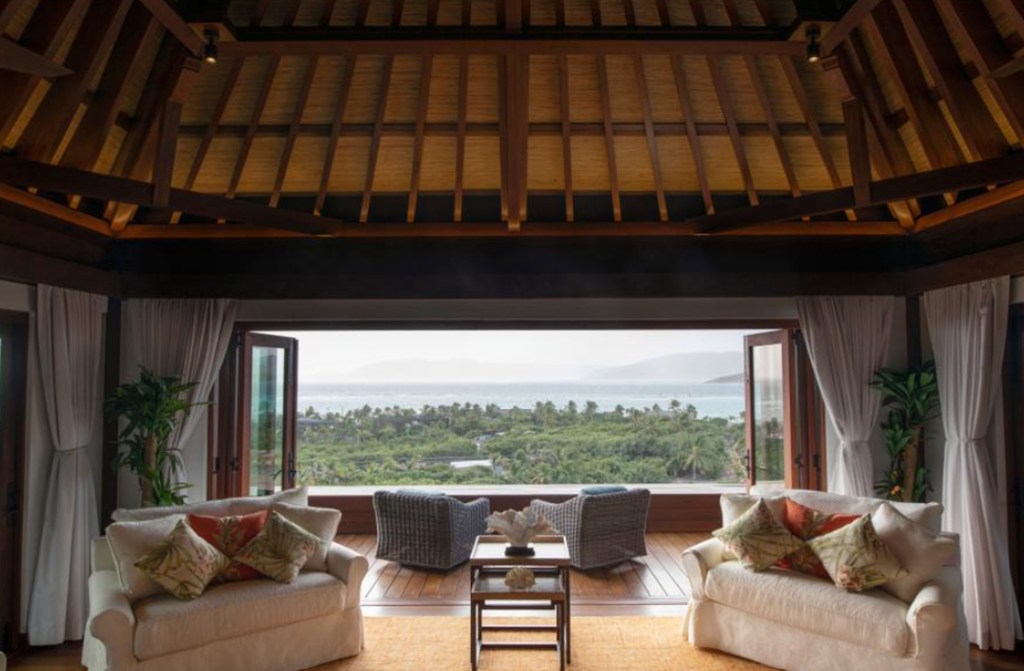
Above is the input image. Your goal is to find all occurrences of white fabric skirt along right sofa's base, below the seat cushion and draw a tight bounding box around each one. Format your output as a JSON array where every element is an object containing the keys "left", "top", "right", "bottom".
[{"left": 683, "top": 599, "right": 970, "bottom": 671}]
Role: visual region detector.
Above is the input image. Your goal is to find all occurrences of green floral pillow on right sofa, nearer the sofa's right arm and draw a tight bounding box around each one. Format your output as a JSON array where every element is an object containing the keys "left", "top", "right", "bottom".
[{"left": 807, "top": 514, "right": 906, "bottom": 592}]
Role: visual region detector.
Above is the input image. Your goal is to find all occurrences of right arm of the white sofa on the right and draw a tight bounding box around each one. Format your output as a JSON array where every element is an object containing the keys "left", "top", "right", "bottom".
[{"left": 906, "top": 567, "right": 967, "bottom": 668}]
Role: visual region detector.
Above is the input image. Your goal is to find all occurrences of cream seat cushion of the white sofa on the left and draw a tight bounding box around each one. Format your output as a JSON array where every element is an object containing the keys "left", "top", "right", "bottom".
[{"left": 134, "top": 572, "right": 346, "bottom": 660}]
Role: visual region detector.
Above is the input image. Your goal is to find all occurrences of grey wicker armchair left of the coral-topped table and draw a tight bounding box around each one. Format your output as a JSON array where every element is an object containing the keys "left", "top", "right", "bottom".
[{"left": 374, "top": 491, "right": 490, "bottom": 571}]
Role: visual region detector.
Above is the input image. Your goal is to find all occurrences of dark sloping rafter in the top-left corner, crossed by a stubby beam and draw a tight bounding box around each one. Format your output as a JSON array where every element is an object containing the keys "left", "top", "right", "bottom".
[{"left": 0, "top": 0, "right": 88, "bottom": 142}]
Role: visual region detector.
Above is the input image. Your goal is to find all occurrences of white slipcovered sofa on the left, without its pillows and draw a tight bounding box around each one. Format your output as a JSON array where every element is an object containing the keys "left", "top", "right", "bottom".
[{"left": 82, "top": 490, "right": 369, "bottom": 671}]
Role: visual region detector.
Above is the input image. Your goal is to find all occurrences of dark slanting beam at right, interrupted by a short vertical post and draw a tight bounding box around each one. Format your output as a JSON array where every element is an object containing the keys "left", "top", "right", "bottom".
[{"left": 690, "top": 154, "right": 1024, "bottom": 234}]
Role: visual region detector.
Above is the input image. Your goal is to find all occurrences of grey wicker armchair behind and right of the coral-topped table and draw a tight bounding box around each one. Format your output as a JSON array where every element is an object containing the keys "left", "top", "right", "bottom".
[{"left": 530, "top": 489, "right": 650, "bottom": 569}]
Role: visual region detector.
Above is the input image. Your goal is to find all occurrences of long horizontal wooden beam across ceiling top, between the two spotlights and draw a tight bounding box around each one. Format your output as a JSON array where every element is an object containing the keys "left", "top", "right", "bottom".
[{"left": 219, "top": 27, "right": 806, "bottom": 56}]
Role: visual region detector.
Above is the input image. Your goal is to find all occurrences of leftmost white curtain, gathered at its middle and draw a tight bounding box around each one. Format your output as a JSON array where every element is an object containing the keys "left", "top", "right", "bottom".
[{"left": 28, "top": 285, "right": 106, "bottom": 645}]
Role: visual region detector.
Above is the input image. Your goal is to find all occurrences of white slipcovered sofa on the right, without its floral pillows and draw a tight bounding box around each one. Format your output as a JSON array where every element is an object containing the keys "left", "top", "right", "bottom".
[{"left": 683, "top": 490, "right": 970, "bottom": 671}]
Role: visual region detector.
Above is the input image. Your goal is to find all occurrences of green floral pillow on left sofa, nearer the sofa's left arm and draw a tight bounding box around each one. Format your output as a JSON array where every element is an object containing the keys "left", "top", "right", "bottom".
[{"left": 135, "top": 519, "right": 230, "bottom": 601}]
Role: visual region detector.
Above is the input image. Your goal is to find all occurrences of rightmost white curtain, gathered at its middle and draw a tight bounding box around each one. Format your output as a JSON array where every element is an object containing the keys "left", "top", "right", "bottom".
[{"left": 925, "top": 278, "right": 1021, "bottom": 649}]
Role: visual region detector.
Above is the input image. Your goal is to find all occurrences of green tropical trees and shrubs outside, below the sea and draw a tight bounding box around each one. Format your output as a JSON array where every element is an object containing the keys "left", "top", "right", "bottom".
[{"left": 297, "top": 401, "right": 746, "bottom": 486}]
